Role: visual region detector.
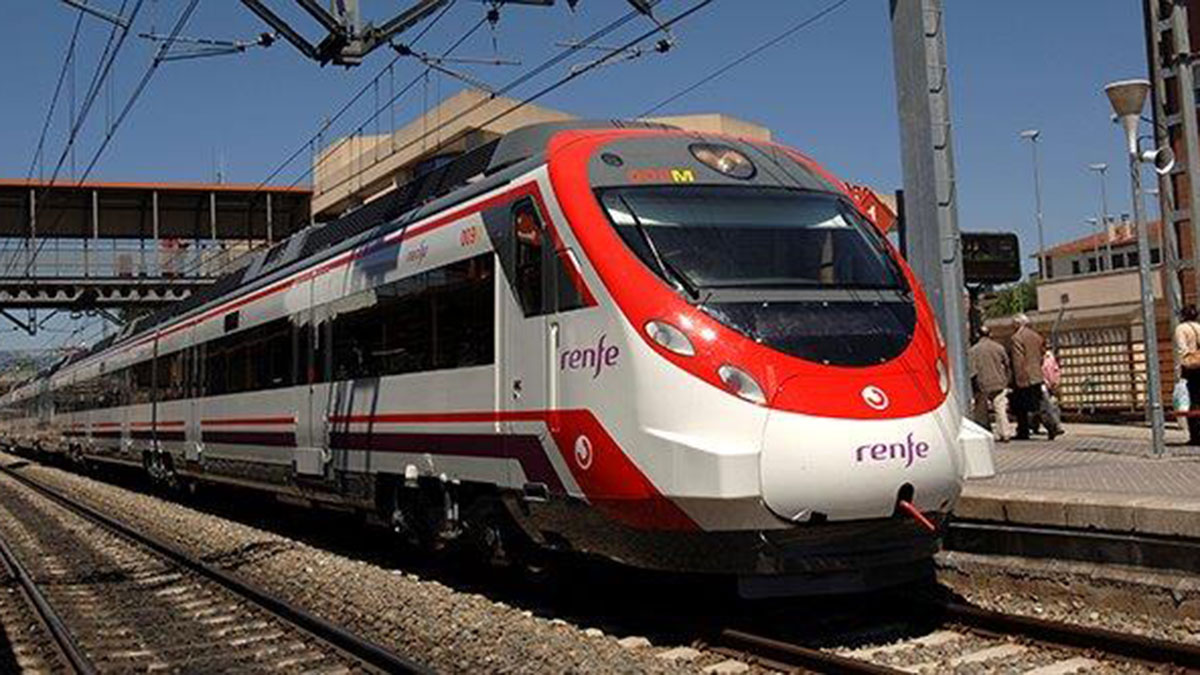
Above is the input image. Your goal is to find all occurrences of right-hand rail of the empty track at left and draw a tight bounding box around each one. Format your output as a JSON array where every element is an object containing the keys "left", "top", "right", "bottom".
[{"left": 0, "top": 465, "right": 433, "bottom": 674}]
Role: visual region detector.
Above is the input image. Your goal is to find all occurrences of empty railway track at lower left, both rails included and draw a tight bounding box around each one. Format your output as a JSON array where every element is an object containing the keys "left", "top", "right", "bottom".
[{"left": 0, "top": 458, "right": 427, "bottom": 673}]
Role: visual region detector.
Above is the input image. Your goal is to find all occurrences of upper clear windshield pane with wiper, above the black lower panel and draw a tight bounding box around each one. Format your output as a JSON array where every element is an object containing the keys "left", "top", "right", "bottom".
[{"left": 602, "top": 186, "right": 904, "bottom": 288}]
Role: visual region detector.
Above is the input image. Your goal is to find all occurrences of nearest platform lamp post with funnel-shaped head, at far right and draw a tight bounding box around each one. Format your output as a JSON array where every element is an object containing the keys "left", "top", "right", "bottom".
[{"left": 1104, "top": 79, "right": 1175, "bottom": 456}]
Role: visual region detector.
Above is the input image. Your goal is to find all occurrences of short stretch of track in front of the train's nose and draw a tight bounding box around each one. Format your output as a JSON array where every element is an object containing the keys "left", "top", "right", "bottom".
[{"left": 702, "top": 598, "right": 1200, "bottom": 675}]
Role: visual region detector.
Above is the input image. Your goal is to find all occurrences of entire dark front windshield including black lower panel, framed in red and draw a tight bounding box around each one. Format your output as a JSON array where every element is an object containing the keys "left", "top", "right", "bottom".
[{"left": 599, "top": 186, "right": 916, "bottom": 365}]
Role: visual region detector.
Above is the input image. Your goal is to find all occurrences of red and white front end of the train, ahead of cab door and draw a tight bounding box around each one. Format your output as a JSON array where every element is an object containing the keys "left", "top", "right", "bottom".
[{"left": 548, "top": 129, "right": 991, "bottom": 596}]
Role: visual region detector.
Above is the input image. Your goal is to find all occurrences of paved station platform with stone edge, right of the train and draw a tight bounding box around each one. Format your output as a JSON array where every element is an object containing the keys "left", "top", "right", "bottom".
[{"left": 947, "top": 424, "right": 1200, "bottom": 572}]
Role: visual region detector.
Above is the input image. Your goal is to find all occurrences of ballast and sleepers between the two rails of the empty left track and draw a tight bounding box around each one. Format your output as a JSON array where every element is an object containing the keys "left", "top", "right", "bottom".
[{"left": 0, "top": 468, "right": 374, "bottom": 674}]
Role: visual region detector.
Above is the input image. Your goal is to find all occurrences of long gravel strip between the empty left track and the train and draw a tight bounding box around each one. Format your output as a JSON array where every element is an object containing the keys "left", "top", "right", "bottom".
[{"left": 0, "top": 453, "right": 748, "bottom": 673}]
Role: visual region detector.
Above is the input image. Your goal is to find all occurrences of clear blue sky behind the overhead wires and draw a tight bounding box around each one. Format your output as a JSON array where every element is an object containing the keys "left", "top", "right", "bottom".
[{"left": 0, "top": 0, "right": 1146, "bottom": 346}]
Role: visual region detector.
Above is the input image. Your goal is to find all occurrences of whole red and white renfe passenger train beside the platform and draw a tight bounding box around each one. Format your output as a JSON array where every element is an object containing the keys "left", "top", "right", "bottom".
[{"left": 0, "top": 120, "right": 992, "bottom": 597}]
